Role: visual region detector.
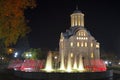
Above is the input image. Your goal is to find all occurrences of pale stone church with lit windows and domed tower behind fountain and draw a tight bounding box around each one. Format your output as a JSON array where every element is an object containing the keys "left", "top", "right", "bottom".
[{"left": 59, "top": 9, "right": 100, "bottom": 68}]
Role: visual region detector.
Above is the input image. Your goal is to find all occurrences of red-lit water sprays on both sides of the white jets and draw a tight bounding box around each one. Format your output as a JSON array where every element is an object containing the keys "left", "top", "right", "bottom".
[{"left": 8, "top": 59, "right": 107, "bottom": 72}]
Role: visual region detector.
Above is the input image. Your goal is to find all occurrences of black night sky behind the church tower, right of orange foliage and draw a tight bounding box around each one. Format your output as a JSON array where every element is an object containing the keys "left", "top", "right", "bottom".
[{"left": 26, "top": 0, "right": 120, "bottom": 54}]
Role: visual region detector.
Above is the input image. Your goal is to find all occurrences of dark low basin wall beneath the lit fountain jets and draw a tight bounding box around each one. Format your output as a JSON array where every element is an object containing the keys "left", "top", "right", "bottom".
[{"left": 14, "top": 70, "right": 113, "bottom": 80}]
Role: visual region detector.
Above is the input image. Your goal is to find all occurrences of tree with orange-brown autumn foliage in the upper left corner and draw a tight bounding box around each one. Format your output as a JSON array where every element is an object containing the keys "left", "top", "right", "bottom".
[{"left": 0, "top": 0, "right": 36, "bottom": 47}]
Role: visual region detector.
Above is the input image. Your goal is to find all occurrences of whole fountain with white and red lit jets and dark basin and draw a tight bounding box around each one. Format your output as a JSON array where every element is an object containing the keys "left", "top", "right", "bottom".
[{"left": 14, "top": 51, "right": 112, "bottom": 80}]
